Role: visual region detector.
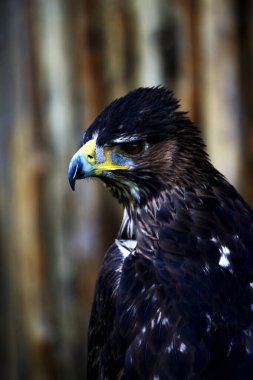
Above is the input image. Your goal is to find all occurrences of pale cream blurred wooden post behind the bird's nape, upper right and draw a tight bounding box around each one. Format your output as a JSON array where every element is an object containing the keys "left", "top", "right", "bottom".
[{"left": 199, "top": 0, "right": 241, "bottom": 185}]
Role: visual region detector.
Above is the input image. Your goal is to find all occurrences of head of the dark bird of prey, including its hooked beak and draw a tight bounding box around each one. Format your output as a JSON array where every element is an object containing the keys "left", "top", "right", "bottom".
[{"left": 68, "top": 87, "right": 211, "bottom": 204}]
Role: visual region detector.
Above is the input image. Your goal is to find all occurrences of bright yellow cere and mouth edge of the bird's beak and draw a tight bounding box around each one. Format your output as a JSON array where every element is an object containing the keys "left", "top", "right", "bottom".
[{"left": 80, "top": 139, "right": 128, "bottom": 174}]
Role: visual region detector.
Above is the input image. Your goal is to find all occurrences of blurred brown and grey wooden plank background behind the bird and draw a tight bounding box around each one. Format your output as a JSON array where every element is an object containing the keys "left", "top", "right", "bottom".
[{"left": 0, "top": 0, "right": 253, "bottom": 380}]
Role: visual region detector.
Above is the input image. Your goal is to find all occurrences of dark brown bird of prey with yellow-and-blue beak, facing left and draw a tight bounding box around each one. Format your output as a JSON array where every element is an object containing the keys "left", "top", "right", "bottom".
[{"left": 68, "top": 87, "right": 253, "bottom": 380}]
